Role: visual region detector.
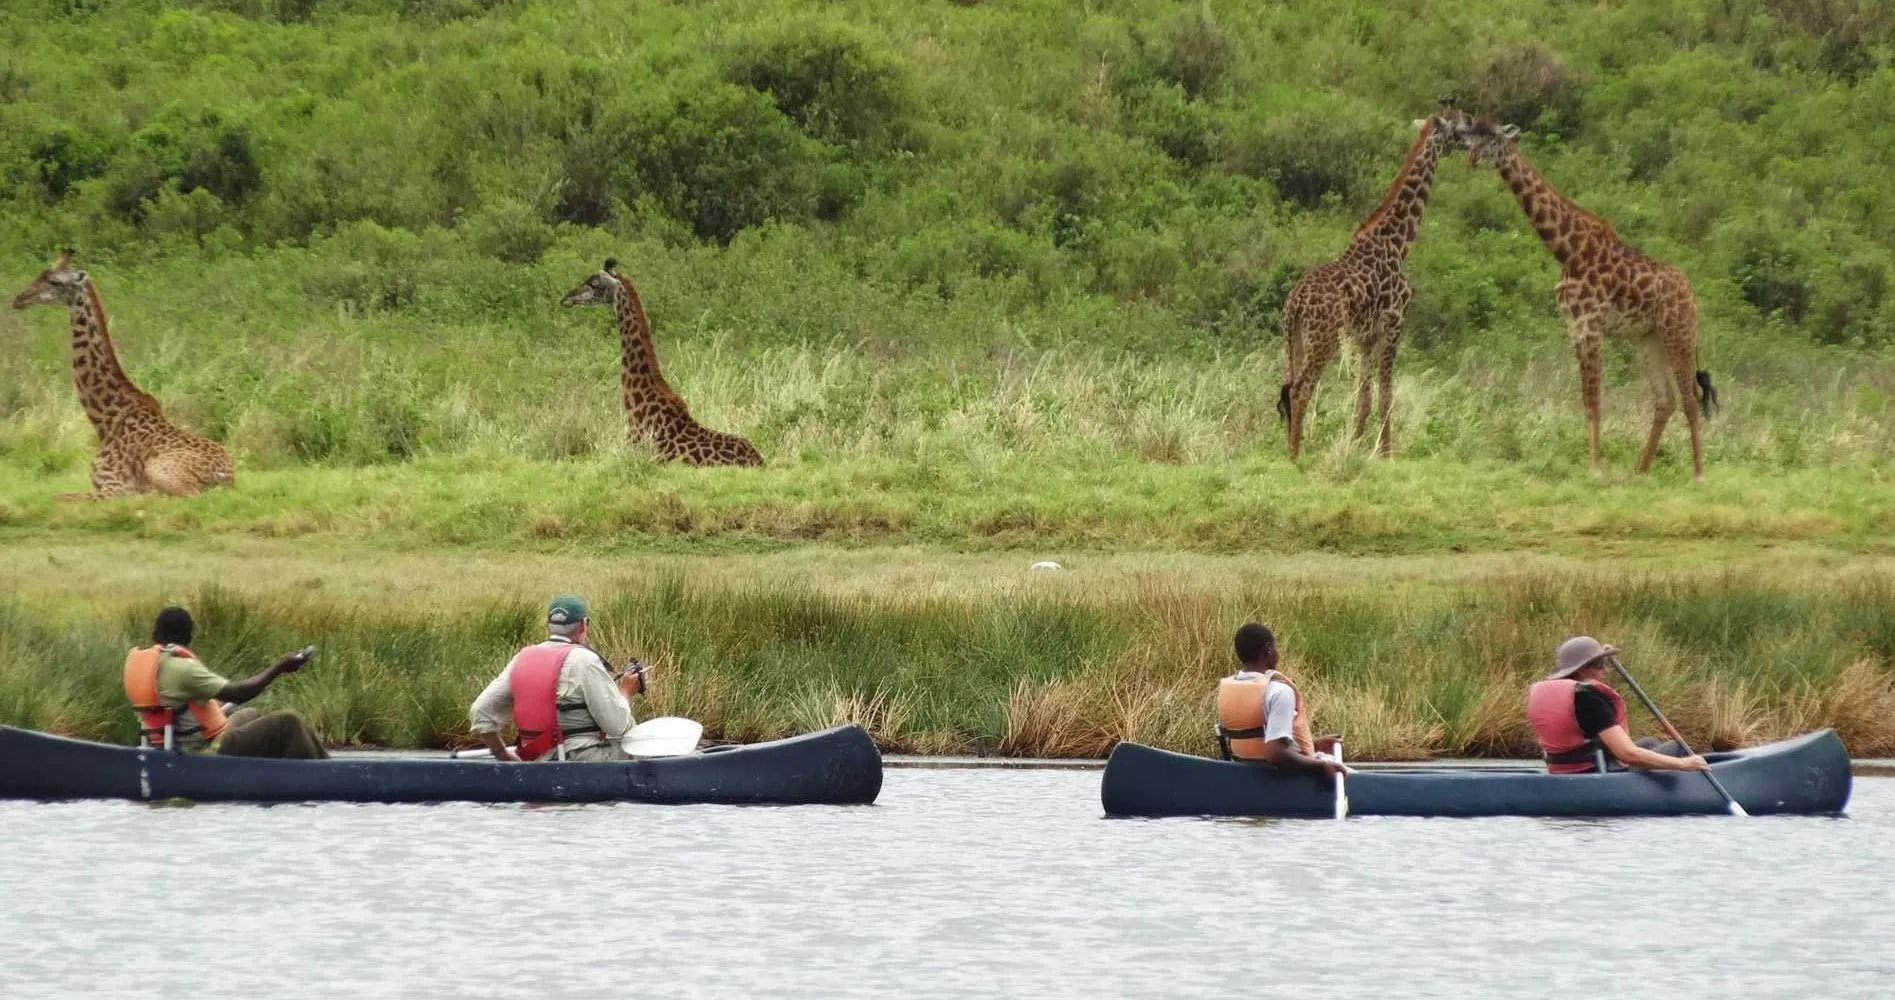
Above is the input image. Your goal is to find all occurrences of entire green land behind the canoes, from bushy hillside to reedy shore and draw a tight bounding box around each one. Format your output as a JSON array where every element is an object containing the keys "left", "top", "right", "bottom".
[{"left": 0, "top": 0, "right": 1895, "bottom": 756}]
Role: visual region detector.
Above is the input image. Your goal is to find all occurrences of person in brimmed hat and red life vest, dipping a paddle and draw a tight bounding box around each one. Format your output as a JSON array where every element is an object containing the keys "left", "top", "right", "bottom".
[{"left": 1527, "top": 636, "right": 1709, "bottom": 775}]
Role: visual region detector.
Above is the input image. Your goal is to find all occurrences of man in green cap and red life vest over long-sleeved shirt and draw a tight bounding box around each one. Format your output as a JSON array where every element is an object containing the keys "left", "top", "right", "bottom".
[{"left": 468, "top": 595, "right": 646, "bottom": 761}]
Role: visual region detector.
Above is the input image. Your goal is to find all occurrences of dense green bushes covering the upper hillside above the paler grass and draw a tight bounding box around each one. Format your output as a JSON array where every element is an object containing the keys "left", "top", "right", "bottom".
[{"left": 0, "top": 0, "right": 1895, "bottom": 352}]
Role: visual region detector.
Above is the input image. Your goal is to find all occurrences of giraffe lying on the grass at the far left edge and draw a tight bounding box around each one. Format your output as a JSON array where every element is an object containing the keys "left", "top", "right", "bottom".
[{"left": 13, "top": 250, "right": 237, "bottom": 500}]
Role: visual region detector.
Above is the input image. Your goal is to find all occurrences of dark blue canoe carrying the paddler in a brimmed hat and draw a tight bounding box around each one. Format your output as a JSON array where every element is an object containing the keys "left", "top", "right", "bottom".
[{"left": 1099, "top": 729, "right": 1850, "bottom": 818}]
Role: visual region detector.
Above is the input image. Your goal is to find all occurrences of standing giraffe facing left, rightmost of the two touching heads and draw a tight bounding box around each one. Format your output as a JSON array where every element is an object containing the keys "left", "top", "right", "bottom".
[{"left": 1455, "top": 119, "right": 1717, "bottom": 481}]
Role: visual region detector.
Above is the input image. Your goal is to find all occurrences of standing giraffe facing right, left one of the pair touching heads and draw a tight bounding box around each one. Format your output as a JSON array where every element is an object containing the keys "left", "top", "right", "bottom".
[{"left": 1277, "top": 116, "right": 1457, "bottom": 460}]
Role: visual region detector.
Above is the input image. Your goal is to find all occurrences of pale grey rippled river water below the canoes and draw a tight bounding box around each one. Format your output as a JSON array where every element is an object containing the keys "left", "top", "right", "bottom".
[{"left": 0, "top": 771, "right": 1895, "bottom": 1000}]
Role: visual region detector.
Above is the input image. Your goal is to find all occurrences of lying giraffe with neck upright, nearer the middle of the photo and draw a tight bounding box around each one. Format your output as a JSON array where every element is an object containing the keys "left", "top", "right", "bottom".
[{"left": 559, "top": 258, "right": 764, "bottom": 466}]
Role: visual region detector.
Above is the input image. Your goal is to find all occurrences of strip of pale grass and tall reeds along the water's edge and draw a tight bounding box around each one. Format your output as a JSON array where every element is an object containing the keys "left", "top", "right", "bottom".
[{"left": 0, "top": 553, "right": 1895, "bottom": 759}]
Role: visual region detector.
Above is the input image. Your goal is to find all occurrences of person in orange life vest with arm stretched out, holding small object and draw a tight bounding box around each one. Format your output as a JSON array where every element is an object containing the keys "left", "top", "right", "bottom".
[{"left": 125, "top": 608, "right": 330, "bottom": 759}]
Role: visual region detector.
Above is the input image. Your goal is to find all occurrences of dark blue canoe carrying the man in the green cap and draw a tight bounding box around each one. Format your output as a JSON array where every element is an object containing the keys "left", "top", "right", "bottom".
[{"left": 0, "top": 725, "right": 881, "bottom": 805}]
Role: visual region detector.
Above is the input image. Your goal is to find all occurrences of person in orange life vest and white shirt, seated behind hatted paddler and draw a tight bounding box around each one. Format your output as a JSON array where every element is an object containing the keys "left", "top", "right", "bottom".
[{"left": 1217, "top": 621, "right": 1342, "bottom": 778}]
